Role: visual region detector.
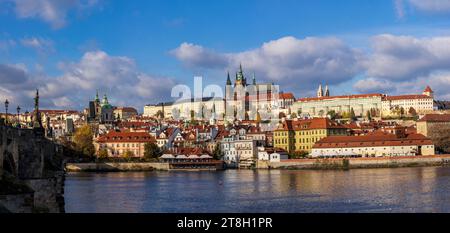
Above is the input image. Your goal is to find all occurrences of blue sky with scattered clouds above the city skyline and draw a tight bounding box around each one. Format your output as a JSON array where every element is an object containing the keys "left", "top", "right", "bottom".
[{"left": 0, "top": 0, "right": 450, "bottom": 111}]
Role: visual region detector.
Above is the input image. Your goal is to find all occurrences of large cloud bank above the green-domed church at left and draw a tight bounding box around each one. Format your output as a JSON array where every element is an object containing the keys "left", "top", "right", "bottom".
[{"left": 0, "top": 51, "right": 176, "bottom": 110}]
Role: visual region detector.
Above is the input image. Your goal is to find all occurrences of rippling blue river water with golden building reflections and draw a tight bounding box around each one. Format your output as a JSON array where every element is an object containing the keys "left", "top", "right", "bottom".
[{"left": 65, "top": 167, "right": 450, "bottom": 213}]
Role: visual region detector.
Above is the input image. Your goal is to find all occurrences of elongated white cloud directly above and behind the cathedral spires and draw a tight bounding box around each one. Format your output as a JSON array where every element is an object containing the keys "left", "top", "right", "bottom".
[{"left": 171, "top": 36, "right": 364, "bottom": 89}]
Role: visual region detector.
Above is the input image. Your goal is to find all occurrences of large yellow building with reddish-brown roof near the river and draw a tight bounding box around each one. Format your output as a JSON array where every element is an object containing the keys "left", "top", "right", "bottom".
[{"left": 274, "top": 118, "right": 347, "bottom": 153}]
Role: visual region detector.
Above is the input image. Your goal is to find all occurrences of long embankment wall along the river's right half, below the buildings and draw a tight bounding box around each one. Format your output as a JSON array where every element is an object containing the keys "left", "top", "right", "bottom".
[{"left": 257, "top": 155, "right": 450, "bottom": 170}]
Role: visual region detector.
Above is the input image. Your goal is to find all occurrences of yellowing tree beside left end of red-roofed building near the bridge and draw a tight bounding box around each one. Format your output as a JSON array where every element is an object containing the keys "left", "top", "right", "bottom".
[{"left": 73, "top": 124, "right": 95, "bottom": 157}]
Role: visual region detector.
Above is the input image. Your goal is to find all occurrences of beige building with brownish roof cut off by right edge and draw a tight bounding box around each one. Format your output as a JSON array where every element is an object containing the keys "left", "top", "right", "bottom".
[{"left": 416, "top": 114, "right": 450, "bottom": 137}]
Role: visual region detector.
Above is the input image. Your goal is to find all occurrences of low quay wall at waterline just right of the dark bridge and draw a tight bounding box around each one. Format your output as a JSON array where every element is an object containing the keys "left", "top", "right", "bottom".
[{"left": 66, "top": 162, "right": 169, "bottom": 172}]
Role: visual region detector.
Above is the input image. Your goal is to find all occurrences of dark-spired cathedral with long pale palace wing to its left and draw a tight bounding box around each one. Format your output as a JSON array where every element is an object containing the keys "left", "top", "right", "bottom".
[{"left": 144, "top": 66, "right": 295, "bottom": 121}]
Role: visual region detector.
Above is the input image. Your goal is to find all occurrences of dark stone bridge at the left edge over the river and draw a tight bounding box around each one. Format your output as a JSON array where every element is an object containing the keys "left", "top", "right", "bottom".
[{"left": 0, "top": 124, "right": 64, "bottom": 212}]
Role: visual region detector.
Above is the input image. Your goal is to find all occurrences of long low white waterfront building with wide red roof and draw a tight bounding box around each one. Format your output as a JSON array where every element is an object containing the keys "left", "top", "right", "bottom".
[{"left": 310, "top": 132, "right": 435, "bottom": 158}]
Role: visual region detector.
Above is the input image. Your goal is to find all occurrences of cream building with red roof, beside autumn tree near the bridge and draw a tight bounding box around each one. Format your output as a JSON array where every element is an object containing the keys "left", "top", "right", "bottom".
[{"left": 94, "top": 131, "right": 156, "bottom": 158}]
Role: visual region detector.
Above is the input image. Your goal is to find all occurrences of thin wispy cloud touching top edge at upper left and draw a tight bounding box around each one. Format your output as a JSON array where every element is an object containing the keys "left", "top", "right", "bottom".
[{"left": 9, "top": 0, "right": 98, "bottom": 29}]
